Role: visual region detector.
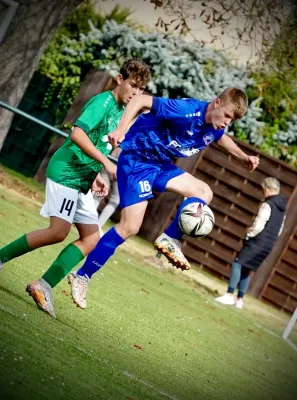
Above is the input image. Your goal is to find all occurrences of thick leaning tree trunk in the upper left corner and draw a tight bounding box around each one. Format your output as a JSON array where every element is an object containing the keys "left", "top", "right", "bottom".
[{"left": 0, "top": 0, "right": 81, "bottom": 150}]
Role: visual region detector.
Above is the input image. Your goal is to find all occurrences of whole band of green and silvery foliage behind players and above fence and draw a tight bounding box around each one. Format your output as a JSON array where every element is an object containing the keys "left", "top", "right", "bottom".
[{"left": 38, "top": 3, "right": 297, "bottom": 166}]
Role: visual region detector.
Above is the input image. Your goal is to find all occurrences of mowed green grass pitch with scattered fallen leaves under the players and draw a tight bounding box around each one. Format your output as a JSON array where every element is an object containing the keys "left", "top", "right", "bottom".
[{"left": 0, "top": 188, "right": 297, "bottom": 400}]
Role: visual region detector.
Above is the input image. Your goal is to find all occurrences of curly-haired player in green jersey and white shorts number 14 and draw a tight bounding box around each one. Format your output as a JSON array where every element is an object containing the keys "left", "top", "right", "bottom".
[{"left": 0, "top": 58, "right": 150, "bottom": 317}]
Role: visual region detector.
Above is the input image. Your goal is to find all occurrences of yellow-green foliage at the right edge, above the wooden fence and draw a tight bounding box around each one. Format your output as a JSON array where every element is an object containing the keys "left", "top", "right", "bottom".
[{"left": 234, "top": 8, "right": 297, "bottom": 167}]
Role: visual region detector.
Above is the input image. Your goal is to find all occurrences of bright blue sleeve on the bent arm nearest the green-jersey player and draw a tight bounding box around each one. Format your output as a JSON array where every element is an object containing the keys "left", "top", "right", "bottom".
[{"left": 151, "top": 97, "right": 200, "bottom": 119}]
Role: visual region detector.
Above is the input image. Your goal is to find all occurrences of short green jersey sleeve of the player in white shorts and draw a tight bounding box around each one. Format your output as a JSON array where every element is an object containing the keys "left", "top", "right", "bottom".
[{"left": 74, "top": 96, "right": 106, "bottom": 133}]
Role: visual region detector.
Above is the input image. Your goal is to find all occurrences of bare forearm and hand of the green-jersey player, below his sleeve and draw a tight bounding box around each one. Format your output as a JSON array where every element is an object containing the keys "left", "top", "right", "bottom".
[{"left": 70, "top": 126, "right": 116, "bottom": 180}]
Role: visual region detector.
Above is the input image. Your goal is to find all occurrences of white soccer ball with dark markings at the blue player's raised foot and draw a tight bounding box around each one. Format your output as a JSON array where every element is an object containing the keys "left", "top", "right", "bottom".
[{"left": 178, "top": 201, "right": 215, "bottom": 238}]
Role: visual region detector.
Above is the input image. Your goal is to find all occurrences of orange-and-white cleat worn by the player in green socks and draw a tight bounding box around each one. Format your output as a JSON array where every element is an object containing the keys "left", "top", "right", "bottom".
[{"left": 26, "top": 279, "right": 56, "bottom": 318}]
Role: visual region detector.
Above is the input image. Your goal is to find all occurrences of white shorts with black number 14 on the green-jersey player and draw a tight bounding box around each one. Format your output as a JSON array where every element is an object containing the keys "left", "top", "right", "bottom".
[{"left": 40, "top": 178, "right": 98, "bottom": 225}]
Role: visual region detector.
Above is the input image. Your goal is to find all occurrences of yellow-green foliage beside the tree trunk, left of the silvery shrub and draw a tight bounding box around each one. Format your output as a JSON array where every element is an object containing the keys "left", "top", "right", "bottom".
[{"left": 38, "top": 1, "right": 136, "bottom": 125}]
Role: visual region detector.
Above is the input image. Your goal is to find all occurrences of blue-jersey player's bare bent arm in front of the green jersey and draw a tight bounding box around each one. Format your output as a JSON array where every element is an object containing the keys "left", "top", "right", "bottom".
[{"left": 108, "top": 94, "right": 153, "bottom": 146}]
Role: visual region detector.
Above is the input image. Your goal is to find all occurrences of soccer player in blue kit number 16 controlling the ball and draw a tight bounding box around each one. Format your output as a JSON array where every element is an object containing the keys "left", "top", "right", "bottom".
[{"left": 68, "top": 88, "right": 259, "bottom": 308}]
